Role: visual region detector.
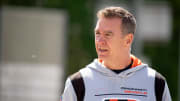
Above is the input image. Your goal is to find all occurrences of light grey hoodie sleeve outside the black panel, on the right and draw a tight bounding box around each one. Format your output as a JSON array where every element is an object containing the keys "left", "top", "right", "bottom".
[{"left": 162, "top": 82, "right": 172, "bottom": 101}]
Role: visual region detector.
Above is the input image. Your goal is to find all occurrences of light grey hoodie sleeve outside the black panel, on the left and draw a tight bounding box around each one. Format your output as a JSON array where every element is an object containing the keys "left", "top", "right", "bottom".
[{"left": 60, "top": 78, "right": 77, "bottom": 101}]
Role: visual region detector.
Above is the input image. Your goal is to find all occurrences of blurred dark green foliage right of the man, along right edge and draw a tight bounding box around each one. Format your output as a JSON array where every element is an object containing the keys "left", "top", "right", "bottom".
[{"left": 144, "top": 0, "right": 180, "bottom": 101}]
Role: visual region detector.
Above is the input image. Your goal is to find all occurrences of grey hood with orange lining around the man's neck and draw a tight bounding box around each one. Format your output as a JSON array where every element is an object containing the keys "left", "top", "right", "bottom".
[{"left": 87, "top": 55, "right": 148, "bottom": 78}]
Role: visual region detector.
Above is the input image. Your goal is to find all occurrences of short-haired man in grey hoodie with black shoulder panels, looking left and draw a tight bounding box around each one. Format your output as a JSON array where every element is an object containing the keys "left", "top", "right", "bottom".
[{"left": 62, "top": 7, "right": 171, "bottom": 101}]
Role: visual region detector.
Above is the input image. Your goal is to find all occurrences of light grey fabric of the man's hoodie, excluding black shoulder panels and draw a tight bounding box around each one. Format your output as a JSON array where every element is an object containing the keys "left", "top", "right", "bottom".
[{"left": 61, "top": 55, "right": 171, "bottom": 101}]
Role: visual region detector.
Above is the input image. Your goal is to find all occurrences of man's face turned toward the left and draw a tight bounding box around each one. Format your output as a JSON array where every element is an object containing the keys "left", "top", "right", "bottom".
[{"left": 95, "top": 18, "right": 128, "bottom": 61}]
